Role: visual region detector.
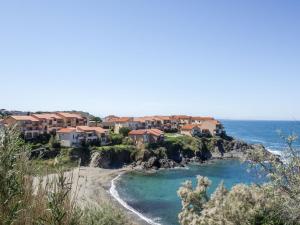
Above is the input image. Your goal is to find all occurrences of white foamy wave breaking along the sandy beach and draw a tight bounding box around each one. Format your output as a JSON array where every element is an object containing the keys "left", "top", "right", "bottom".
[{"left": 109, "top": 174, "right": 161, "bottom": 225}]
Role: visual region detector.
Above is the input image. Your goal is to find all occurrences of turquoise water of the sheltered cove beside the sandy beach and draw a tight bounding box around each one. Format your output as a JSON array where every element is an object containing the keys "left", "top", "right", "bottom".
[{"left": 116, "top": 160, "right": 261, "bottom": 225}]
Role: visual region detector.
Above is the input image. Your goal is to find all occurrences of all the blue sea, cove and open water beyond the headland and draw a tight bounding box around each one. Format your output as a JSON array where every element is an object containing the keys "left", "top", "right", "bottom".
[{"left": 110, "top": 120, "right": 300, "bottom": 225}]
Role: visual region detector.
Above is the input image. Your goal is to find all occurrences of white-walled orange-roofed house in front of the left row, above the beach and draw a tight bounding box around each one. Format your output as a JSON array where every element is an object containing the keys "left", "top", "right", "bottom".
[{"left": 56, "top": 126, "right": 109, "bottom": 147}]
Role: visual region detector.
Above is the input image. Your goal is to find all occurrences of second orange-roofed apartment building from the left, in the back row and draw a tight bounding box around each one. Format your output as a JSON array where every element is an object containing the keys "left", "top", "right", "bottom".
[{"left": 32, "top": 113, "right": 64, "bottom": 133}]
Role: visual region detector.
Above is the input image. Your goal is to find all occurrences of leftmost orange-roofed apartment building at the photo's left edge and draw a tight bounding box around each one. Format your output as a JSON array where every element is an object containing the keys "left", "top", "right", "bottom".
[{"left": 3, "top": 116, "right": 43, "bottom": 140}]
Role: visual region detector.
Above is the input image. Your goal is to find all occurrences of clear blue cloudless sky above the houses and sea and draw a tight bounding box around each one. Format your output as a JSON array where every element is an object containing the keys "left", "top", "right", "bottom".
[{"left": 0, "top": 0, "right": 300, "bottom": 120}]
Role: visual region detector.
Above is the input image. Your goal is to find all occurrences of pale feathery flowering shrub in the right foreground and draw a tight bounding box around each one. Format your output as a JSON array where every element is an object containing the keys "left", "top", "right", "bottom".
[{"left": 178, "top": 136, "right": 300, "bottom": 225}]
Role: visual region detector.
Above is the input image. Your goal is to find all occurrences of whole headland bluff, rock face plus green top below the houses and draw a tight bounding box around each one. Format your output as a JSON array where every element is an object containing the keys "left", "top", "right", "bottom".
[{"left": 90, "top": 136, "right": 264, "bottom": 170}]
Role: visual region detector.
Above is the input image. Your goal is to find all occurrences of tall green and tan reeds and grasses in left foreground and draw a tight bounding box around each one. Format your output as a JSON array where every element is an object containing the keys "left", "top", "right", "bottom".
[{"left": 0, "top": 125, "right": 129, "bottom": 225}]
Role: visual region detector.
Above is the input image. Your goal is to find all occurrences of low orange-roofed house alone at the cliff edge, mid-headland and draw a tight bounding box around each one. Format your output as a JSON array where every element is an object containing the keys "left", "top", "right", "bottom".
[{"left": 128, "top": 129, "right": 164, "bottom": 145}]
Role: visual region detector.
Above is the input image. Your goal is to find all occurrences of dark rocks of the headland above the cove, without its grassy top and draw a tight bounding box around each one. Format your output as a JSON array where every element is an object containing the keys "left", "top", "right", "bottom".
[{"left": 90, "top": 137, "right": 265, "bottom": 170}]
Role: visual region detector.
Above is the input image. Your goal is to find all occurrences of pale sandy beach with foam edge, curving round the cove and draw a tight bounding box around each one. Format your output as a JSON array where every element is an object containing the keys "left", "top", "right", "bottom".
[{"left": 66, "top": 151, "right": 268, "bottom": 225}]
